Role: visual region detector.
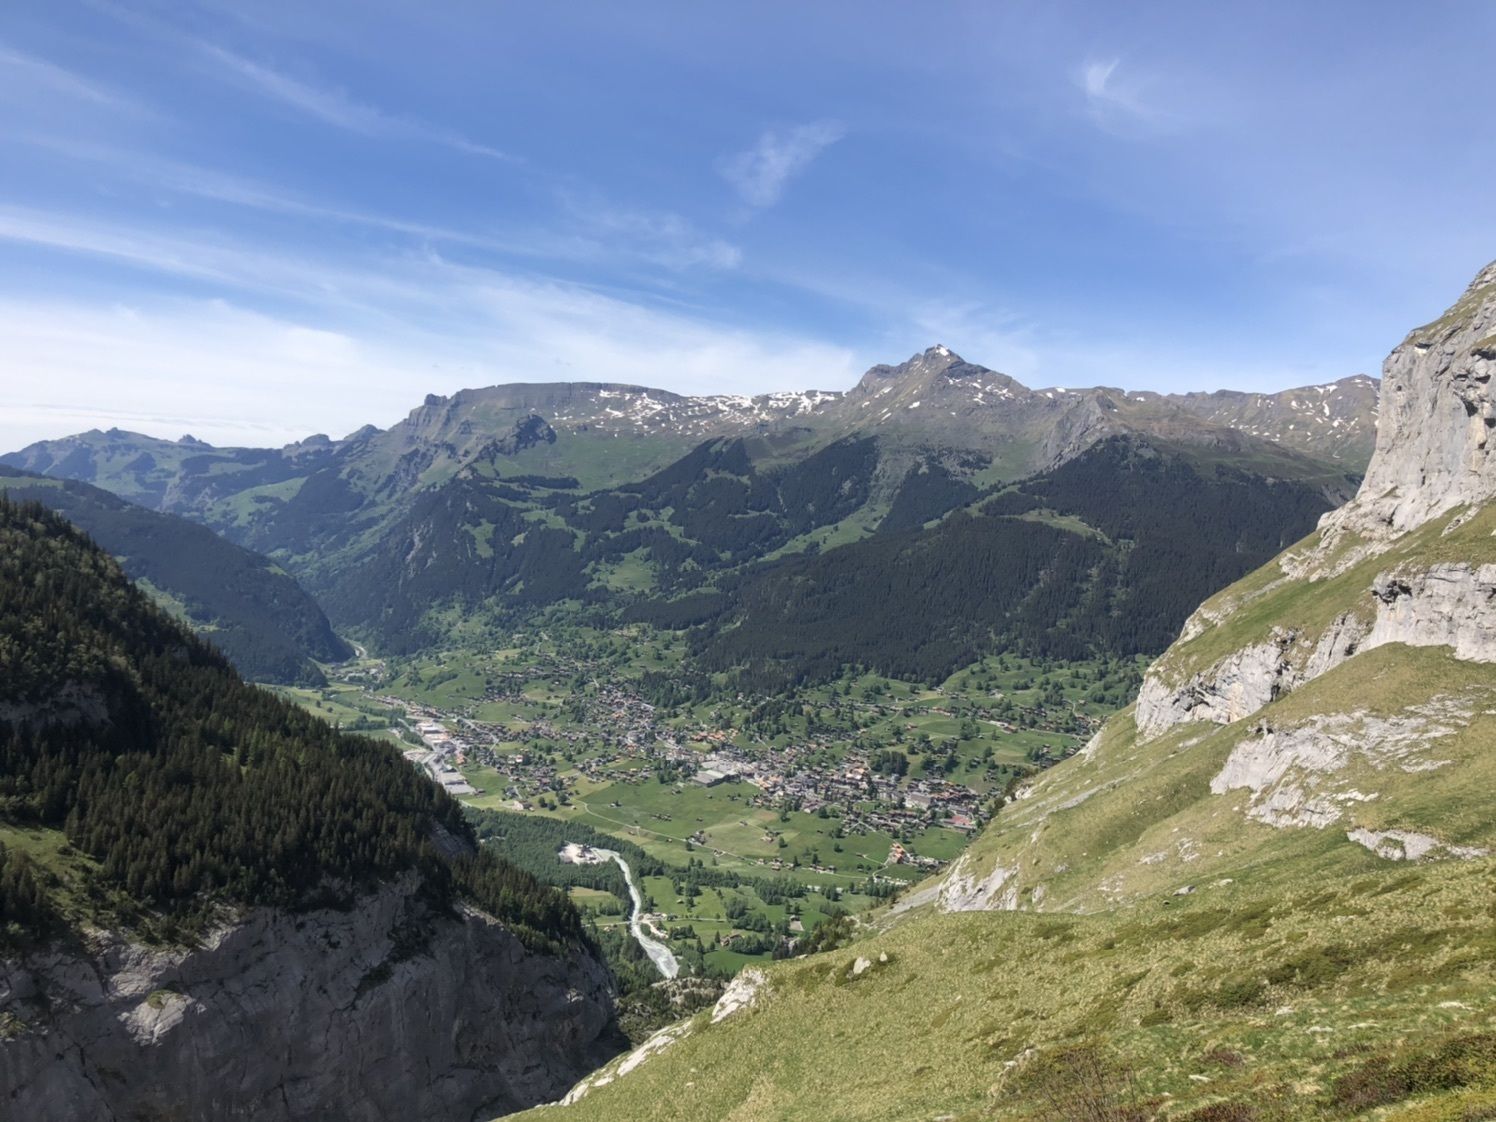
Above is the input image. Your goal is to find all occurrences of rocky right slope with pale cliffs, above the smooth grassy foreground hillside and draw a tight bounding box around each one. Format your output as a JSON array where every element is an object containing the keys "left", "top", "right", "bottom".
[{"left": 927, "top": 263, "right": 1496, "bottom": 913}]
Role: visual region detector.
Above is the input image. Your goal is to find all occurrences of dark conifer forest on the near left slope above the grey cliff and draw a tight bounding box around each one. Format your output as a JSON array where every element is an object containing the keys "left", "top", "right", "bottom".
[{"left": 0, "top": 497, "right": 583, "bottom": 947}]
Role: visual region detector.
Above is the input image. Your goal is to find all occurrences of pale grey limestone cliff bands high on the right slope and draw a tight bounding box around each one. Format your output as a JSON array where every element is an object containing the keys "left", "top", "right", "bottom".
[{"left": 1137, "top": 263, "right": 1496, "bottom": 741}]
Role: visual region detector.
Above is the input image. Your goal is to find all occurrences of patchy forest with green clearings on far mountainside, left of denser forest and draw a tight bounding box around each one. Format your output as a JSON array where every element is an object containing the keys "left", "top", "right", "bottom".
[{"left": 316, "top": 438, "right": 878, "bottom": 654}]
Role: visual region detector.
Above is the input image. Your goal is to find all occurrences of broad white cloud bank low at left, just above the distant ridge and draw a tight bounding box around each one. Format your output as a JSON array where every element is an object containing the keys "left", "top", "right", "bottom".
[{"left": 0, "top": 211, "right": 854, "bottom": 449}]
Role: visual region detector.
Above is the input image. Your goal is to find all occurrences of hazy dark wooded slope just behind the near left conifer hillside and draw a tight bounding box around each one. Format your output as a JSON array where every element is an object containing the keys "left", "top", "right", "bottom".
[{"left": 0, "top": 465, "right": 353, "bottom": 682}]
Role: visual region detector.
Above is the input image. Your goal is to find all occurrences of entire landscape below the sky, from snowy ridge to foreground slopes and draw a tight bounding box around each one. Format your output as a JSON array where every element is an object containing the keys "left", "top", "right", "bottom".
[{"left": 0, "top": 265, "right": 1496, "bottom": 1122}]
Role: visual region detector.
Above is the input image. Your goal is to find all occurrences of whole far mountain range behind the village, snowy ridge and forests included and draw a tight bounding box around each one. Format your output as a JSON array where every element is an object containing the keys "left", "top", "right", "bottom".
[{"left": 3, "top": 346, "right": 1376, "bottom": 685}]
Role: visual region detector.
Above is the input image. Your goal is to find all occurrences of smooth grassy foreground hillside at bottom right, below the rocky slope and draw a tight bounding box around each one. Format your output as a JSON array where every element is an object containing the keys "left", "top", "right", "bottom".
[{"left": 524, "top": 856, "right": 1496, "bottom": 1122}]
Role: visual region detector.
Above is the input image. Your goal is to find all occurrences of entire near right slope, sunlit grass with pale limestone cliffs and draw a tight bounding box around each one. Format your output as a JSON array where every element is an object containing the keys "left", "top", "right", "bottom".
[{"left": 511, "top": 265, "right": 1496, "bottom": 1122}]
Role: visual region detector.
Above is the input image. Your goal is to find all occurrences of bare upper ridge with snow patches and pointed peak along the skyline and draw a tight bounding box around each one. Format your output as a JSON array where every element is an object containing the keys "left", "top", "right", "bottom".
[{"left": 0, "top": 346, "right": 1376, "bottom": 521}]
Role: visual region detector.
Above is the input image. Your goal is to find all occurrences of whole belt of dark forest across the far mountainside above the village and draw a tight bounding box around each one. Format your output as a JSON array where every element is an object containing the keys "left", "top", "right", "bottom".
[{"left": 303, "top": 437, "right": 1330, "bottom": 693}]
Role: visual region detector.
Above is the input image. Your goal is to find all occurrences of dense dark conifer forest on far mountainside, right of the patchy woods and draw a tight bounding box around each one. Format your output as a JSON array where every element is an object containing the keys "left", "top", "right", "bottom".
[{"left": 649, "top": 437, "right": 1328, "bottom": 690}]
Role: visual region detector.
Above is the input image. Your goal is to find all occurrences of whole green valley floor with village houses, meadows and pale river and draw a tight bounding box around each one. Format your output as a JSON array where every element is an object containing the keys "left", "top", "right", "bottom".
[{"left": 269, "top": 627, "right": 1138, "bottom": 972}]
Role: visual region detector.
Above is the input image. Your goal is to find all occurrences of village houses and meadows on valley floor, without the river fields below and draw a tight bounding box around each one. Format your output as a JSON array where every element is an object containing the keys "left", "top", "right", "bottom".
[{"left": 294, "top": 636, "right": 1132, "bottom": 872}]
